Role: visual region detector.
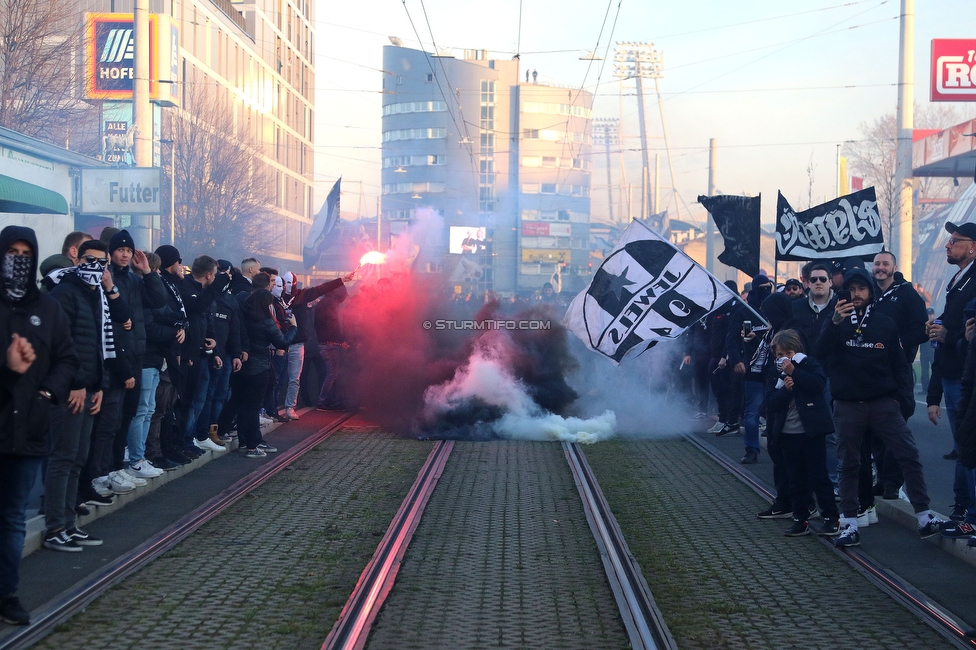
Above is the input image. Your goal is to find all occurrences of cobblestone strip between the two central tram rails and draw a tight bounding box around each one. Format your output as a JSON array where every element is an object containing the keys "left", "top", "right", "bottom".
[{"left": 367, "top": 442, "right": 629, "bottom": 650}]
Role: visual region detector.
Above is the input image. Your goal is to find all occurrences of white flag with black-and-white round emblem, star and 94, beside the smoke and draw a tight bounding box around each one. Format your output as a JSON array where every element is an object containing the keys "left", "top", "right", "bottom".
[{"left": 566, "top": 220, "right": 738, "bottom": 364}]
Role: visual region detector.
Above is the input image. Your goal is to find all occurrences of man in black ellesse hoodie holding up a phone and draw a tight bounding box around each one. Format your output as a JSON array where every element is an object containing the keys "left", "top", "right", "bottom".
[{"left": 817, "top": 268, "right": 945, "bottom": 547}]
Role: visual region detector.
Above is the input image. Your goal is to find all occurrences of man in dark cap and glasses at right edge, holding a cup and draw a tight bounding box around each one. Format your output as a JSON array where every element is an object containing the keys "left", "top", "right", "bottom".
[{"left": 925, "top": 222, "right": 976, "bottom": 519}]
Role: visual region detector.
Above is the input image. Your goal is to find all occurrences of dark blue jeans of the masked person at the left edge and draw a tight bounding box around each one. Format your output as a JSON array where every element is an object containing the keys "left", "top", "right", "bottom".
[{"left": 0, "top": 454, "right": 42, "bottom": 598}]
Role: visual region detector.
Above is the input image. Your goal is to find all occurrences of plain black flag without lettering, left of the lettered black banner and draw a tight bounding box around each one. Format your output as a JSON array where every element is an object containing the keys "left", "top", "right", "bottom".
[{"left": 698, "top": 195, "right": 762, "bottom": 276}]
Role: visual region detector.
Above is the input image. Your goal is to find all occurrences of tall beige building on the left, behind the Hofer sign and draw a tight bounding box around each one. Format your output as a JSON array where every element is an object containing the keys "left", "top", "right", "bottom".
[{"left": 80, "top": 0, "right": 315, "bottom": 264}]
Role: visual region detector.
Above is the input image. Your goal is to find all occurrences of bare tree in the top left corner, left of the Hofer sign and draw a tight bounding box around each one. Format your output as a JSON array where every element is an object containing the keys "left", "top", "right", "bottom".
[{"left": 0, "top": 0, "right": 98, "bottom": 149}]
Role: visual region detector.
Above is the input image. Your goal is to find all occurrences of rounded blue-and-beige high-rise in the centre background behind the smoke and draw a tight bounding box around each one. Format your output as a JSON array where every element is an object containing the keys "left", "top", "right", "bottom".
[{"left": 382, "top": 46, "right": 593, "bottom": 294}]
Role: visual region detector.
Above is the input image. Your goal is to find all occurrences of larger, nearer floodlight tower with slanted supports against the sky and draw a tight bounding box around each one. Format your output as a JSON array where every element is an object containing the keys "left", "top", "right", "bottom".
[{"left": 613, "top": 41, "right": 681, "bottom": 230}]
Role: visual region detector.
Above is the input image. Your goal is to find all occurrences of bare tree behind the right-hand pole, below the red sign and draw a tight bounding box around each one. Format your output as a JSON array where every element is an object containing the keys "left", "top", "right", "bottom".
[{"left": 843, "top": 105, "right": 964, "bottom": 246}]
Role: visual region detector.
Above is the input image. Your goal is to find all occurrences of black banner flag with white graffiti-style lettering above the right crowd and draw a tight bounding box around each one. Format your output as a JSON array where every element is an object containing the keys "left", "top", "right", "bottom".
[{"left": 776, "top": 187, "right": 884, "bottom": 262}]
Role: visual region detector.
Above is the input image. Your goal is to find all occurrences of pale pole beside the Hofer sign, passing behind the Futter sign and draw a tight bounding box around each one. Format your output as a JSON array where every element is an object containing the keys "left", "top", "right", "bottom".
[{"left": 130, "top": 0, "right": 153, "bottom": 250}]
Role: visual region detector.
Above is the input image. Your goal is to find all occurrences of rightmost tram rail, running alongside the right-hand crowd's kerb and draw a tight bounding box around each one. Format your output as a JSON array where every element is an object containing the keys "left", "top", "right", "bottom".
[{"left": 684, "top": 434, "right": 976, "bottom": 649}]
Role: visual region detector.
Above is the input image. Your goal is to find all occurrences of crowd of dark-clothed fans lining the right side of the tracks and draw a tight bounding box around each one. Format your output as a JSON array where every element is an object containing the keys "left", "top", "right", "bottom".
[{"left": 682, "top": 223, "right": 976, "bottom": 547}]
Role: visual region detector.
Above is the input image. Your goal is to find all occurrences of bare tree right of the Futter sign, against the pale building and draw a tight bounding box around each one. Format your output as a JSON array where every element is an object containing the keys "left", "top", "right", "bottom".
[{"left": 170, "top": 82, "right": 279, "bottom": 259}]
